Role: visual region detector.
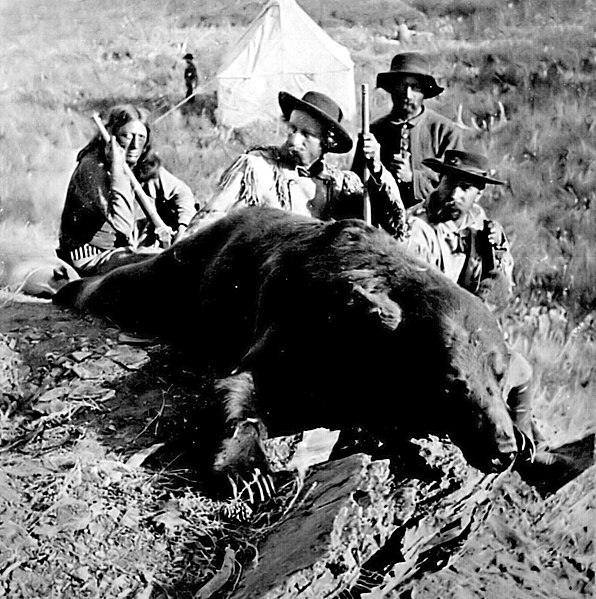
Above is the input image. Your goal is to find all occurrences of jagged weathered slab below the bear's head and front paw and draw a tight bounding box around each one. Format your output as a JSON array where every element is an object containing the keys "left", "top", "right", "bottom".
[{"left": 232, "top": 437, "right": 503, "bottom": 599}]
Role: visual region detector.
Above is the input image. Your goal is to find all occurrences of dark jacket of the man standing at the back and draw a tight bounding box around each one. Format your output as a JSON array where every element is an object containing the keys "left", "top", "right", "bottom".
[{"left": 352, "top": 106, "right": 463, "bottom": 208}]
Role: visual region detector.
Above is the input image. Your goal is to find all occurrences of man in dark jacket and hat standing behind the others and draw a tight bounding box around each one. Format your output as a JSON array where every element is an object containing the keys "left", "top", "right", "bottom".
[{"left": 352, "top": 52, "right": 463, "bottom": 208}]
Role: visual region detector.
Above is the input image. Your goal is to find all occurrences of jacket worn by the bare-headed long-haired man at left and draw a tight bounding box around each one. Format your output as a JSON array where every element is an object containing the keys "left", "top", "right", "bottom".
[{"left": 59, "top": 148, "right": 195, "bottom": 253}]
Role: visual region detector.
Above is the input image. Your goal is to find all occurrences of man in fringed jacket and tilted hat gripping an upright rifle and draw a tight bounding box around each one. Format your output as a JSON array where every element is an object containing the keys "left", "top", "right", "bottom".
[{"left": 188, "top": 91, "right": 405, "bottom": 237}]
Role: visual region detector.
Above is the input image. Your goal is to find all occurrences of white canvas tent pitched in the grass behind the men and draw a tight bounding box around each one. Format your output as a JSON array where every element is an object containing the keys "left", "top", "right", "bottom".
[{"left": 217, "top": 0, "right": 356, "bottom": 127}]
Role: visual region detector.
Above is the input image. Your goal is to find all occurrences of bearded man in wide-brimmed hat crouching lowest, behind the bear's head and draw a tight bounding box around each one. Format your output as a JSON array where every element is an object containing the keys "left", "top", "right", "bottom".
[{"left": 403, "top": 150, "right": 572, "bottom": 478}]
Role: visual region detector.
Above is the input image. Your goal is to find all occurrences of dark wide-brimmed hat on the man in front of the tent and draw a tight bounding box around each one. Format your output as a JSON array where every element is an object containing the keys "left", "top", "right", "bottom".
[{"left": 279, "top": 92, "right": 352, "bottom": 154}]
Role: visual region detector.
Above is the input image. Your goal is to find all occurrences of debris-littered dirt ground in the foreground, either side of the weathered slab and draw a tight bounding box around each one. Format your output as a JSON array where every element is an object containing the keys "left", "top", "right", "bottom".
[{"left": 0, "top": 294, "right": 596, "bottom": 599}]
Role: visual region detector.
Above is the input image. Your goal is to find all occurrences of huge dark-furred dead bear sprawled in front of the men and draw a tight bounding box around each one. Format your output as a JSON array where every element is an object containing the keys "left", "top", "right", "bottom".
[{"left": 55, "top": 208, "right": 517, "bottom": 474}]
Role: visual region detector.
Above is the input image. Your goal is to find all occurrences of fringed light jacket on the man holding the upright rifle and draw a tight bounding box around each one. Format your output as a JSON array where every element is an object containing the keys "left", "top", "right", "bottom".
[{"left": 187, "top": 146, "right": 405, "bottom": 237}]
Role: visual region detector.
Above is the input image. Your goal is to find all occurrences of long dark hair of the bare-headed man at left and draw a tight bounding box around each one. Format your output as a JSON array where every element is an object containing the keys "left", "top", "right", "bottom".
[{"left": 77, "top": 104, "right": 161, "bottom": 181}]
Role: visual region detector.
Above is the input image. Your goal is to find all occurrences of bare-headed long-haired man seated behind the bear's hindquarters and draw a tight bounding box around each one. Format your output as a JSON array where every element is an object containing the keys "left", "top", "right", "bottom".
[{"left": 58, "top": 104, "right": 195, "bottom": 276}]
